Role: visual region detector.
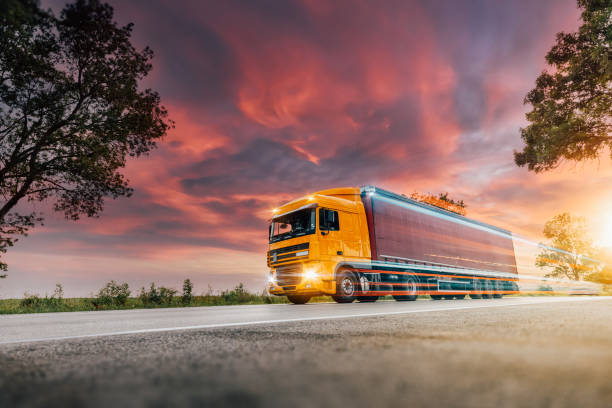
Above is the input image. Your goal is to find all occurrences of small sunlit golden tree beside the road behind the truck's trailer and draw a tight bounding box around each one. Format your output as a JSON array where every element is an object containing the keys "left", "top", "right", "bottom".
[{"left": 536, "top": 213, "right": 595, "bottom": 280}]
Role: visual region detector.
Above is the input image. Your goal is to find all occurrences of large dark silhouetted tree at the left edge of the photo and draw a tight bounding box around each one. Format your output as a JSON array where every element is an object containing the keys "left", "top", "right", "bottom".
[{"left": 0, "top": 0, "right": 173, "bottom": 270}]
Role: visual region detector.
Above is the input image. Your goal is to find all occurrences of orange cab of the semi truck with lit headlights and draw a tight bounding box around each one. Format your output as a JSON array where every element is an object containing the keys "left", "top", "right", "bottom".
[{"left": 268, "top": 187, "right": 371, "bottom": 303}]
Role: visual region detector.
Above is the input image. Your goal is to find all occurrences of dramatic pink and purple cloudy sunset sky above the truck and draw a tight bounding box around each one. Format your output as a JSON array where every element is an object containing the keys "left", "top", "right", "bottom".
[{"left": 0, "top": 0, "right": 612, "bottom": 297}]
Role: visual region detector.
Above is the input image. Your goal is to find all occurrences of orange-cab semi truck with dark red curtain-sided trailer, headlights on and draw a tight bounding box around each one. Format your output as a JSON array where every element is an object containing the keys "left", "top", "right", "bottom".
[{"left": 267, "top": 186, "right": 519, "bottom": 304}]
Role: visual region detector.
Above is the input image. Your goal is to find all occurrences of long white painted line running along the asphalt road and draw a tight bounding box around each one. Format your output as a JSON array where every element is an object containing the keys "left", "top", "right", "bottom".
[{"left": 0, "top": 297, "right": 610, "bottom": 345}]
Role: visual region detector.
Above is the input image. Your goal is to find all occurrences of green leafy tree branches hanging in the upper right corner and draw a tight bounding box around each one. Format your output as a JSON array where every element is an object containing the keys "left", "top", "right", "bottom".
[{"left": 514, "top": 0, "right": 612, "bottom": 172}]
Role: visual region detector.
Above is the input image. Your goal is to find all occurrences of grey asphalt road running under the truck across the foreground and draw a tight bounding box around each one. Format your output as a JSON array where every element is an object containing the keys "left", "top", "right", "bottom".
[{"left": 0, "top": 297, "right": 612, "bottom": 407}]
